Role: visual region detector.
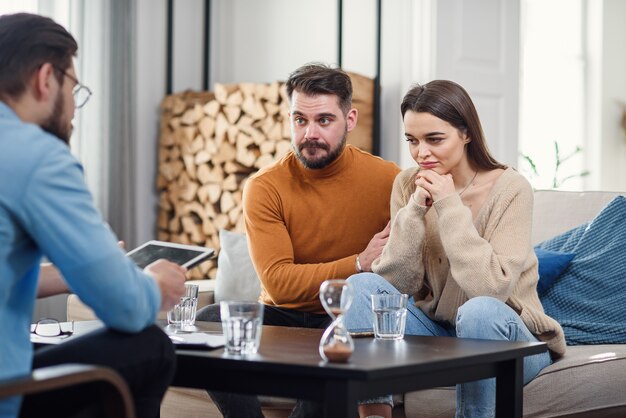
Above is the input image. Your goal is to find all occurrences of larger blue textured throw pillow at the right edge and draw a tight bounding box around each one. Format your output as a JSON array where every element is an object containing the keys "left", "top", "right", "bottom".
[{"left": 541, "top": 196, "right": 626, "bottom": 345}]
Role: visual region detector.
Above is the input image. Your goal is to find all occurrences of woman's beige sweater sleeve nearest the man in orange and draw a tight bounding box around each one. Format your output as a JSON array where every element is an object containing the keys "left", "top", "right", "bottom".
[{"left": 372, "top": 173, "right": 428, "bottom": 295}]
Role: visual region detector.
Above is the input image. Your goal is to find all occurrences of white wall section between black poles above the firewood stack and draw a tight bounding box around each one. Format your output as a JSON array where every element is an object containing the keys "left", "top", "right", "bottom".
[{"left": 213, "top": 0, "right": 337, "bottom": 83}]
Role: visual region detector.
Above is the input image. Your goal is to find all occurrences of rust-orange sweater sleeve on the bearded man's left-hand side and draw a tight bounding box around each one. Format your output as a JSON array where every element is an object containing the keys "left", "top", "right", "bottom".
[{"left": 243, "top": 178, "right": 356, "bottom": 311}]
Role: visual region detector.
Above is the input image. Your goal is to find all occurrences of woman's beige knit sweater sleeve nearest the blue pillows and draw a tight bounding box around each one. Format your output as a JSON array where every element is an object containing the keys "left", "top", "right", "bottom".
[{"left": 433, "top": 182, "right": 532, "bottom": 301}]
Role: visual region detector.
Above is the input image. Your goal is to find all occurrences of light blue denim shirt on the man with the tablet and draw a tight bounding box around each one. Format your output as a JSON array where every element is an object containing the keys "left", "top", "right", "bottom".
[{"left": 0, "top": 102, "right": 161, "bottom": 418}]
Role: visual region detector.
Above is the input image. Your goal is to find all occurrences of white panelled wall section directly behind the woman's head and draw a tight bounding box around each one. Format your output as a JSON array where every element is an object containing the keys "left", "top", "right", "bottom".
[{"left": 435, "top": 0, "right": 520, "bottom": 166}]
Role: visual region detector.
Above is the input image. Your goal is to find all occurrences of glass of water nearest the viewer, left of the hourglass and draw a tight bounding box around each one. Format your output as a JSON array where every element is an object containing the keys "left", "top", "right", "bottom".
[{"left": 220, "top": 301, "right": 263, "bottom": 355}]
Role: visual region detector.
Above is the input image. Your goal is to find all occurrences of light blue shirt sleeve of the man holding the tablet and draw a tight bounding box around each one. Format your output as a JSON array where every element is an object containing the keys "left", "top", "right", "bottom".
[{"left": 20, "top": 145, "right": 161, "bottom": 332}]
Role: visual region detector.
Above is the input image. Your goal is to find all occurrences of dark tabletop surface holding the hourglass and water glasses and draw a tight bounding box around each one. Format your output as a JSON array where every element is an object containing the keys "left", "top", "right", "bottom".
[{"left": 173, "top": 322, "right": 546, "bottom": 386}]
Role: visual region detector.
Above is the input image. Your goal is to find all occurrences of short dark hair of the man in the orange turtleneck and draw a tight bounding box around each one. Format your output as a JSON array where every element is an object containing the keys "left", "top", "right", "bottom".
[{"left": 286, "top": 63, "right": 352, "bottom": 114}]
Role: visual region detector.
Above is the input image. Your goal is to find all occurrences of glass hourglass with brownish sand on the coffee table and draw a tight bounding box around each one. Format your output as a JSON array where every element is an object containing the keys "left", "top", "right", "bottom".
[{"left": 319, "top": 280, "right": 354, "bottom": 363}]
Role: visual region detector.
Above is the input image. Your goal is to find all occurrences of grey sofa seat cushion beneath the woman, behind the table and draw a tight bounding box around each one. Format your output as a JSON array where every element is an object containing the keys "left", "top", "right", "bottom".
[{"left": 404, "top": 344, "right": 626, "bottom": 418}]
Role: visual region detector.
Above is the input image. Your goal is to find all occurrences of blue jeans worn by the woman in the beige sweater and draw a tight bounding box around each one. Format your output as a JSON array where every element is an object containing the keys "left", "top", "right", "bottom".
[{"left": 345, "top": 273, "right": 552, "bottom": 417}]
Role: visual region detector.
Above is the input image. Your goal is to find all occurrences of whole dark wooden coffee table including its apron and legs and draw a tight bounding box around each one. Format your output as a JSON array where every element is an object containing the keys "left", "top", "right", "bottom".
[{"left": 173, "top": 322, "right": 547, "bottom": 418}]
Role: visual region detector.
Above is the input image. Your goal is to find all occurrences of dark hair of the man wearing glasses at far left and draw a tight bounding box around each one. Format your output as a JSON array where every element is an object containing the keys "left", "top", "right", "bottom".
[{"left": 0, "top": 13, "right": 78, "bottom": 98}]
